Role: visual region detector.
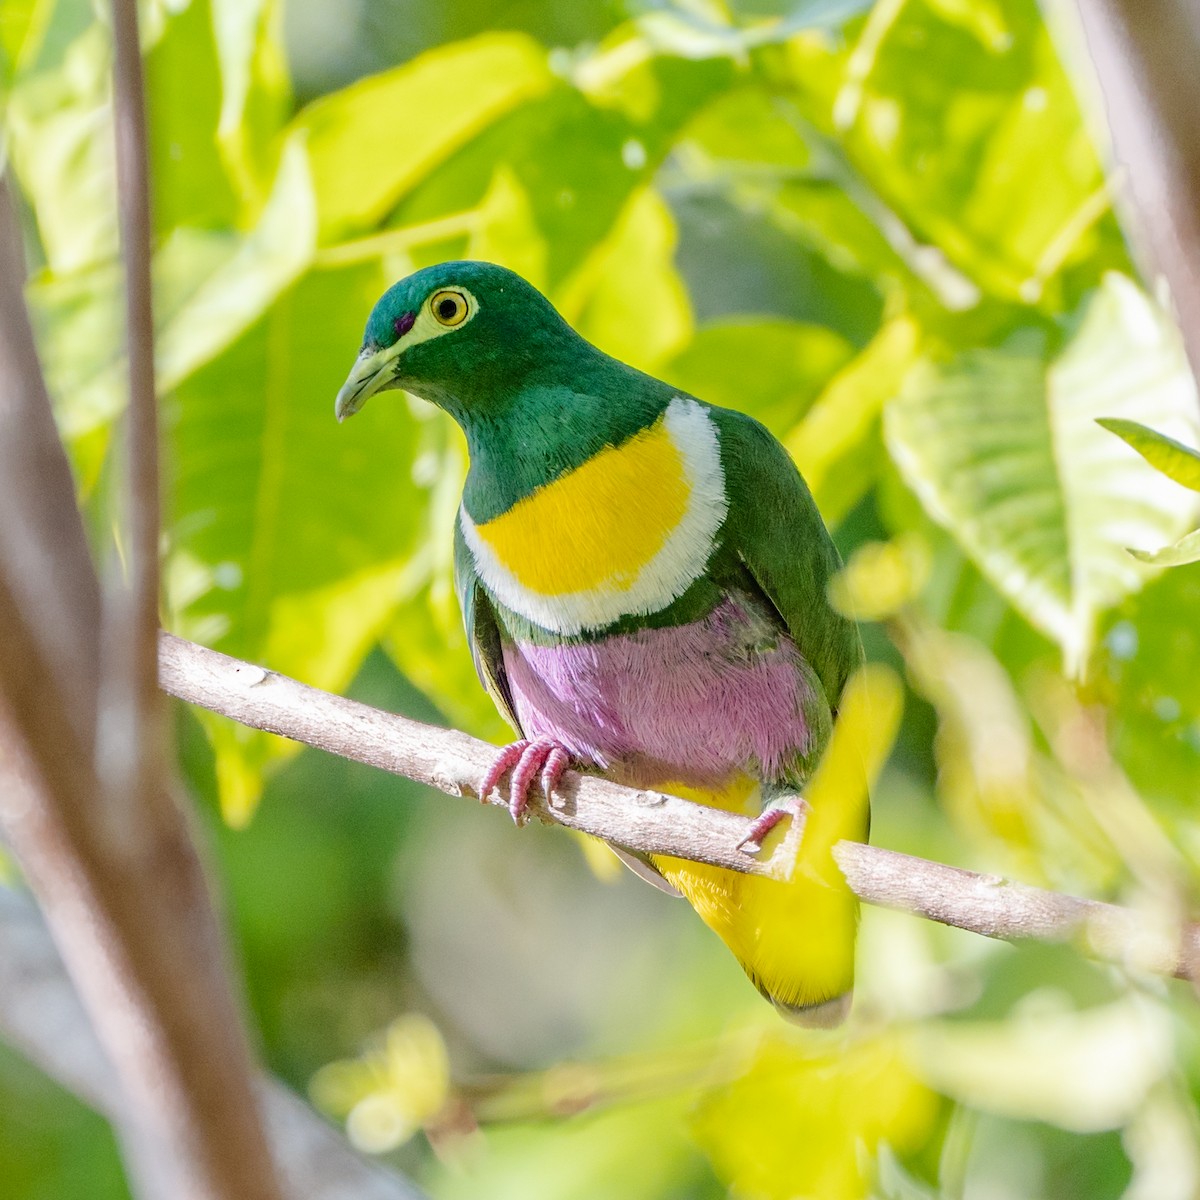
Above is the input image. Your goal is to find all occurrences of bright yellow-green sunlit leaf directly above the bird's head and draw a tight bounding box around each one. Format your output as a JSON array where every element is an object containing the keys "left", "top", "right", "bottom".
[{"left": 295, "top": 34, "right": 554, "bottom": 241}]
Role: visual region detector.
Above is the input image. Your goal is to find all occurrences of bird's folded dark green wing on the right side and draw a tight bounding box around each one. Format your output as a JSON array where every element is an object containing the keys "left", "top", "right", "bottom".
[{"left": 712, "top": 408, "right": 863, "bottom": 713}]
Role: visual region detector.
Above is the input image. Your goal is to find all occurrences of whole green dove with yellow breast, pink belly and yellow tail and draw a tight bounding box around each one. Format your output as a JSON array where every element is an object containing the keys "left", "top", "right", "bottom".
[{"left": 336, "top": 262, "right": 868, "bottom": 1025}]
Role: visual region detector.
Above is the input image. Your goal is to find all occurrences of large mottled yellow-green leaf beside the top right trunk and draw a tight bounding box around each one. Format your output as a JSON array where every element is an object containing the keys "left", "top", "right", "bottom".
[{"left": 790, "top": 0, "right": 1126, "bottom": 302}]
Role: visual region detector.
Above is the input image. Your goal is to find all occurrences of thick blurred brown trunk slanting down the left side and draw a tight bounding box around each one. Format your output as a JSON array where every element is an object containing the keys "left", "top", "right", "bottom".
[{"left": 0, "top": 88, "right": 280, "bottom": 1200}]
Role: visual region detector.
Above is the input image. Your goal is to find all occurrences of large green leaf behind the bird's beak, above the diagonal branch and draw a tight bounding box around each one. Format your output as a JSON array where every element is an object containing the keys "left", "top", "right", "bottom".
[{"left": 163, "top": 265, "right": 426, "bottom": 818}]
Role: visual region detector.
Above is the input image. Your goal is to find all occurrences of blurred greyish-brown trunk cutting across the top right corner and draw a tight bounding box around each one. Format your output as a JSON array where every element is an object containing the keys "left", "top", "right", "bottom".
[{"left": 1078, "top": 0, "right": 1200, "bottom": 378}]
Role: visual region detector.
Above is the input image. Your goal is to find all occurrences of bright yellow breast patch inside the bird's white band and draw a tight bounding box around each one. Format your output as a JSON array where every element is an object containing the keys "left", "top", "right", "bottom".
[{"left": 476, "top": 418, "right": 691, "bottom": 596}]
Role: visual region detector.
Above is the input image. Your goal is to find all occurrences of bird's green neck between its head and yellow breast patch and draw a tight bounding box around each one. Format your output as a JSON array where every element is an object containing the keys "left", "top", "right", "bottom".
[{"left": 451, "top": 347, "right": 676, "bottom": 523}]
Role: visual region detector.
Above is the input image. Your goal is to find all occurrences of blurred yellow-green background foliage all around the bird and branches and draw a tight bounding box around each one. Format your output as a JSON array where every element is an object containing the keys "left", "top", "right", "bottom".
[{"left": 0, "top": 0, "right": 1200, "bottom": 1200}]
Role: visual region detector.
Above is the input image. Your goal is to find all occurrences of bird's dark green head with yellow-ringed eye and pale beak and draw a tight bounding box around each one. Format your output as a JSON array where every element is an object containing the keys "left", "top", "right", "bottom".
[{"left": 335, "top": 262, "right": 580, "bottom": 421}]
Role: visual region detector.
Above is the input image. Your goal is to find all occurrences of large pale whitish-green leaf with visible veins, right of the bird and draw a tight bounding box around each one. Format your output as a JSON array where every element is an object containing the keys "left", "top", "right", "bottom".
[{"left": 884, "top": 275, "right": 1196, "bottom": 671}]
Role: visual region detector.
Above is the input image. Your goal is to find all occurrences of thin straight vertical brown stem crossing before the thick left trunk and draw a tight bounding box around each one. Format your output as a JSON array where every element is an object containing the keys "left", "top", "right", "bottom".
[{"left": 105, "top": 0, "right": 164, "bottom": 806}]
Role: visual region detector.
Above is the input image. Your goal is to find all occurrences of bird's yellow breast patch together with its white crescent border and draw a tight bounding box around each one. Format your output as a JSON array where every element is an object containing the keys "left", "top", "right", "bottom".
[{"left": 458, "top": 396, "right": 728, "bottom": 634}]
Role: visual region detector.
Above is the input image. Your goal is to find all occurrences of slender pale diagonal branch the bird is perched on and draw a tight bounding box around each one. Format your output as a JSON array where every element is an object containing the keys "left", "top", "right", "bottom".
[{"left": 158, "top": 634, "right": 1200, "bottom": 977}]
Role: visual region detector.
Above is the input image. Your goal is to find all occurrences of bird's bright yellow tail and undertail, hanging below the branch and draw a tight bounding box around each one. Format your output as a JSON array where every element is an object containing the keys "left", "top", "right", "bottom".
[{"left": 654, "top": 780, "right": 863, "bottom": 1027}]
